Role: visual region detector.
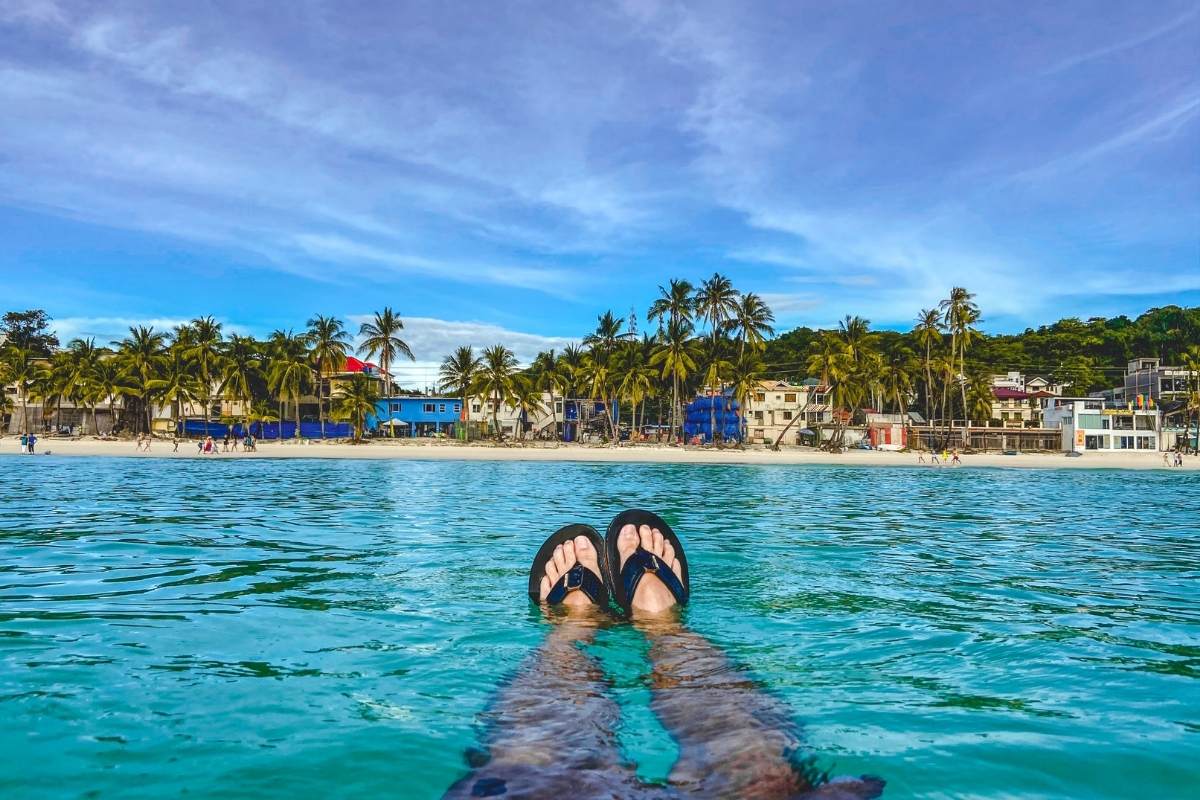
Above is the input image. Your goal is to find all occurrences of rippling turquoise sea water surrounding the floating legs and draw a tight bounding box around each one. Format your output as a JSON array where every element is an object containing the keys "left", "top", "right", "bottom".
[{"left": 0, "top": 456, "right": 1200, "bottom": 800}]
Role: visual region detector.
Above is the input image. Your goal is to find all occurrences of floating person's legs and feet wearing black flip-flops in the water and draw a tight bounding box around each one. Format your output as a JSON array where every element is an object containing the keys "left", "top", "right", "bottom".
[{"left": 445, "top": 510, "right": 883, "bottom": 800}]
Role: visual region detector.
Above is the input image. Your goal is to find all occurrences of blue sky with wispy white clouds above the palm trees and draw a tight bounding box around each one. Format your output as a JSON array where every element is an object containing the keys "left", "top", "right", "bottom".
[{"left": 0, "top": 0, "right": 1200, "bottom": 383}]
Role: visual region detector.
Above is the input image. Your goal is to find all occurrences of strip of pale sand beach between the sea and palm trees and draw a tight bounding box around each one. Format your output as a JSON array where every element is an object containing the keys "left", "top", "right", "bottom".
[{"left": 0, "top": 435, "right": 1200, "bottom": 471}]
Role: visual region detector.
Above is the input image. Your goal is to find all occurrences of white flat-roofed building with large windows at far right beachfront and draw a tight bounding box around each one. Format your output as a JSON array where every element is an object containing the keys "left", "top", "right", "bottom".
[{"left": 1044, "top": 397, "right": 1162, "bottom": 452}]
